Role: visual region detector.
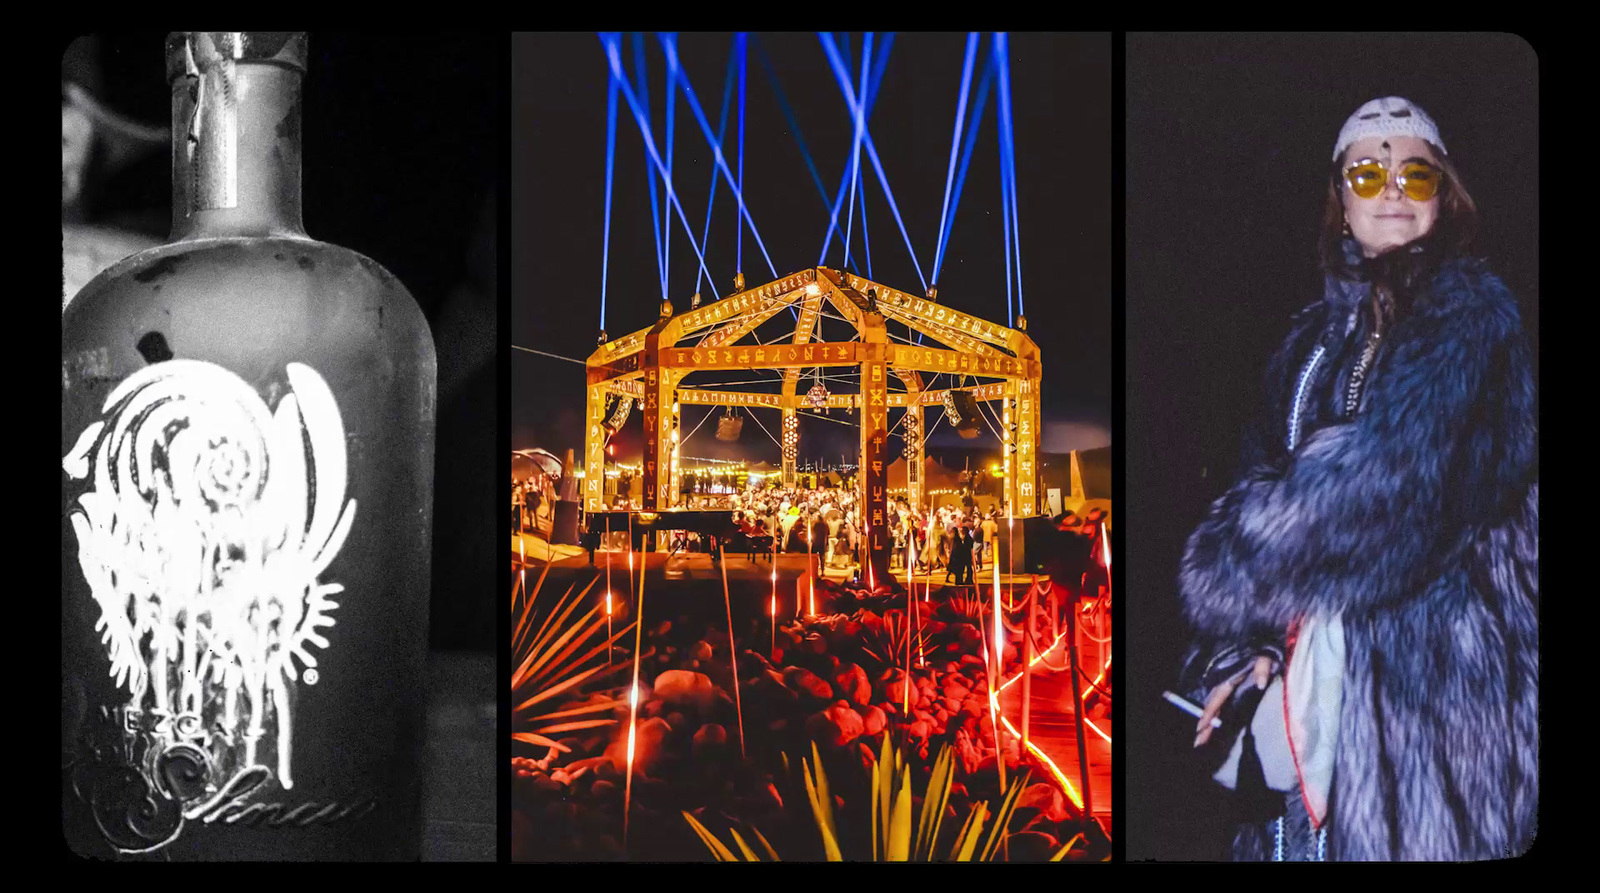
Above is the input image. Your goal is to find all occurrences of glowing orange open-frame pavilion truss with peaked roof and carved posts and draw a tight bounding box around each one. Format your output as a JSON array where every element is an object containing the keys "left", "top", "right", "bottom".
[{"left": 584, "top": 267, "right": 1040, "bottom": 579}]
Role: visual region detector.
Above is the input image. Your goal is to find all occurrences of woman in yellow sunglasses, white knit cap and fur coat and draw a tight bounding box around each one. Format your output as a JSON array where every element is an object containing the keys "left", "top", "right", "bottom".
[{"left": 1179, "top": 98, "right": 1539, "bottom": 859}]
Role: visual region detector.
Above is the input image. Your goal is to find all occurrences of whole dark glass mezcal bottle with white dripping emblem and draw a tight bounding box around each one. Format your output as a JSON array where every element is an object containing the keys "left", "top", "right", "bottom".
[{"left": 61, "top": 32, "right": 435, "bottom": 861}]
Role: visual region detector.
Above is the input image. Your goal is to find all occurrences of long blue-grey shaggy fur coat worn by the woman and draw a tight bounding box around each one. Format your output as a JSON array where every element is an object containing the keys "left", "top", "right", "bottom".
[{"left": 1179, "top": 249, "right": 1539, "bottom": 859}]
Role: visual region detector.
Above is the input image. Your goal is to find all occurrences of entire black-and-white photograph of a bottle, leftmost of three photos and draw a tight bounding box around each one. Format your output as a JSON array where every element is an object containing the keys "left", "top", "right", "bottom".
[{"left": 59, "top": 32, "right": 504, "bottom": 861}]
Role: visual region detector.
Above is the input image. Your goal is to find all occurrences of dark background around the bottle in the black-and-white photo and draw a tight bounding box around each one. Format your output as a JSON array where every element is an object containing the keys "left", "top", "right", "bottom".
[{"left": 62, "top": 32, "right": 507, "bottom": 651}]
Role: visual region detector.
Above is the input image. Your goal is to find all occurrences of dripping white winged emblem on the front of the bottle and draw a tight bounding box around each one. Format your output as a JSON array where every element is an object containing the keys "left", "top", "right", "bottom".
[{"left": 62, "top": 360, "right": 355, "bottom": 803}]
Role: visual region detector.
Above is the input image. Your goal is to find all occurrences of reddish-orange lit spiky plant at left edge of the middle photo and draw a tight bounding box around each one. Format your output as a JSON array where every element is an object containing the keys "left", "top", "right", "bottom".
[{"left": 510, "top": 565, "right": 632, "bottom": 752}]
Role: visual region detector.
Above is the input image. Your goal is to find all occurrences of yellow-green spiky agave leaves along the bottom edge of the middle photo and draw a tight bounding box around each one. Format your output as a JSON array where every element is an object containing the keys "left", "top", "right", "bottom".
[{"left": 683, "top": 736, "right": 1085, "bottom": 863}]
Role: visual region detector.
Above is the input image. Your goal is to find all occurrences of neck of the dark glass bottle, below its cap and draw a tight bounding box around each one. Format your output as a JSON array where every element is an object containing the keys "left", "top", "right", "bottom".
[{"left": 171, "top": 59, "right": 306, "bottom": 242}]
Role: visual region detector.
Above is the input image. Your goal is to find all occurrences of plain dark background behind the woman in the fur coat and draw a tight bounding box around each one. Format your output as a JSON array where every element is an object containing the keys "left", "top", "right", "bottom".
[{"left": 1118, "top": 34, "right": 1539, "bottom": 859}]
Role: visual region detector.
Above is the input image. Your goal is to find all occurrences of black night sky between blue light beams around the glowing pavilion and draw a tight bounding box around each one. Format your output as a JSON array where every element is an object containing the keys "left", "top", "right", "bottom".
[{"left": 510, "top": 34, "right": 1112, "bottom": 464}]
